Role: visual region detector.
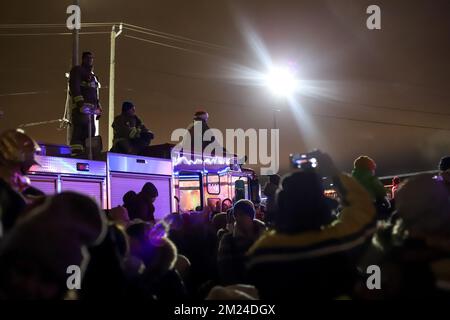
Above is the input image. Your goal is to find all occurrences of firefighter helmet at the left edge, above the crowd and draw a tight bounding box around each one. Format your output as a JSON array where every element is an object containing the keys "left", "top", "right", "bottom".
[{"left": 0, "top": 129, "right": 41, "bottom": 174}]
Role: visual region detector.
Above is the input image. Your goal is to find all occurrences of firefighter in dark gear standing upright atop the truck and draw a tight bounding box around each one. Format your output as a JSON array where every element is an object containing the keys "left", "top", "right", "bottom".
[{"left": 69, "top": 52, "right": 102, "bottom": 155}]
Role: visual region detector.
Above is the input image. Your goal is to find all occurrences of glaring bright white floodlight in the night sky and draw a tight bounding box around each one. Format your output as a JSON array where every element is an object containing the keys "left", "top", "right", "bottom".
[{"left": 265, "top": 67, "right": 298, "bottom": 97}]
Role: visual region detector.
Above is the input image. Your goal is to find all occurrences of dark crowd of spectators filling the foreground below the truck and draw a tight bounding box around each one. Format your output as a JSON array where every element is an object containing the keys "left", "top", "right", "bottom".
[{"left": 0, "top": 130, "right": 450, "bottom": 301}]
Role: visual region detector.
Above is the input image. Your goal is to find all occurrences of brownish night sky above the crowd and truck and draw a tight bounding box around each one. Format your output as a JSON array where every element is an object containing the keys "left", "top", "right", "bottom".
[{"left": 0, "top": 0, "right": 450, "bottom": 175}]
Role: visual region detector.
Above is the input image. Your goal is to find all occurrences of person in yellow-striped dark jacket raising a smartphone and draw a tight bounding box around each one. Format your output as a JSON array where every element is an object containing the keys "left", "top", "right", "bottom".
[{"left": 247, "top": 151, "right": 376, "bottom": 300}]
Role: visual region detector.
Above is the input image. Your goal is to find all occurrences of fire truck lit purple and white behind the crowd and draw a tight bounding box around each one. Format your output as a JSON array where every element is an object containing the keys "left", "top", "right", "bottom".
[{"left": 29, "top": 144, "right": 259, "bottom": 220}]
